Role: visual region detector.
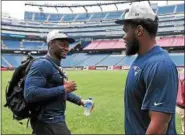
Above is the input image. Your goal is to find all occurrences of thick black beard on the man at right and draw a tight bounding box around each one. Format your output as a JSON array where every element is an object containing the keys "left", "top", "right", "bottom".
[{"left": 126, "top": 36, "right": 139, "bottom": 56}]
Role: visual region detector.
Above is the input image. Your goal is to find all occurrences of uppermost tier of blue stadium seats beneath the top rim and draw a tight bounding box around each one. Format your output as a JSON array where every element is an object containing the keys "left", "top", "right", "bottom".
[{"left": 24, "top": 4, "right": 184, "bottom": 22}]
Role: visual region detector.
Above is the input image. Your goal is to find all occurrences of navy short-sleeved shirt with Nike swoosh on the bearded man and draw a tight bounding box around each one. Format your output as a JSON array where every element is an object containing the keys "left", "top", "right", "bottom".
[{"left": 124, "top": 46, "right": 178, "bottom": 135}]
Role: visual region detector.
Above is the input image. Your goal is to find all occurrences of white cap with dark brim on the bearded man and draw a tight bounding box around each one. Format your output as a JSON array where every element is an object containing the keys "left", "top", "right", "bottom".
[{"left": 115, "top": 2, "right": 156, "bottom": 24}]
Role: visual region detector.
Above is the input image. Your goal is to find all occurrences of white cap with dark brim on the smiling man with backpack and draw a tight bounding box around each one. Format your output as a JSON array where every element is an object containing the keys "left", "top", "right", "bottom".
[{"left": 47, "top": 30, "right": 75, "bottom": 43}]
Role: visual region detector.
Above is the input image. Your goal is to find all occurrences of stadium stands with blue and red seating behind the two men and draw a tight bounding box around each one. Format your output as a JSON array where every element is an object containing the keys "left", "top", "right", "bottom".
[{"left": 1, "top": 1, "right": 184, "bottom": 70}]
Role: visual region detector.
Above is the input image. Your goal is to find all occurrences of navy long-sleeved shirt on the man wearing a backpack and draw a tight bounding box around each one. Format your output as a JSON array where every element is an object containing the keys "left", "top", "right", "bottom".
[{"left": 24, "top": 56, "right": 81, "bottom": 123}]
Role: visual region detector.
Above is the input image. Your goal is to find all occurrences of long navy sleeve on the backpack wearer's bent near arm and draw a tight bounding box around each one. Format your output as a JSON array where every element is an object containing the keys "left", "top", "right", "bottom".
[{"left": 24, "top": 60, "right": 64, "bottom": 103}]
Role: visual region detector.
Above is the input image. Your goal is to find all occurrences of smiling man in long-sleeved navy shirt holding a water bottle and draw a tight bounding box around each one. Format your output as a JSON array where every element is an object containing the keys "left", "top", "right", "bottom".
[{"left": 24, "top": 30, "right": 89, "bottom": 135}]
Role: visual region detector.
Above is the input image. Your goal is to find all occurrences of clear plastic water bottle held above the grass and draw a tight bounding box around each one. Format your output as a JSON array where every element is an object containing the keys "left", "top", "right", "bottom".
[{"left": 84, "top": 98, "right": 93, "bottom": 116}]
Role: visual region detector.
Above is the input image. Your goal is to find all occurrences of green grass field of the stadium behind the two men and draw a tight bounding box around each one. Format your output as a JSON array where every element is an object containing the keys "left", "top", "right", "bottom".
[{"left": 2, "top": 71, "right": 180, "bottom": 134}]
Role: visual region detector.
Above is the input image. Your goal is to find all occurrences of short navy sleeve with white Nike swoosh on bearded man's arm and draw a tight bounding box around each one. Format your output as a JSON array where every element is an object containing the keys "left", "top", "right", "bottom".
[{"left": 141, "top": 62, "right": 178, "bottom": 113}]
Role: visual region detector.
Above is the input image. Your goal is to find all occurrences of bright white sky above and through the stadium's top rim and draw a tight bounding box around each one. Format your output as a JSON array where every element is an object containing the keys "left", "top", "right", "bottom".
[{"left": 2, "top": 0, "right": 184, "bottom": 20}]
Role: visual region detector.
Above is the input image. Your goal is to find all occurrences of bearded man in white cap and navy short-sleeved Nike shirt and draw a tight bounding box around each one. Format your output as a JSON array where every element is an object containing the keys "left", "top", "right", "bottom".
[{"left": 116, "top": 2, "right": 178, "bottom": 135}]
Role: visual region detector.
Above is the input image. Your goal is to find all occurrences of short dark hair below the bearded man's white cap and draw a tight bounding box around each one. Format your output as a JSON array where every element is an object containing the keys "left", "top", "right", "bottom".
[{"left": 124, "top": 16, "right": 159, "bottom": 37}]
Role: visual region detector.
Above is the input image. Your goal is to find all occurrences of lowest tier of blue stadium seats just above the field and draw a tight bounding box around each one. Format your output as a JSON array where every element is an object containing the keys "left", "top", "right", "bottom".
[{"left": 1, "top": 53, "right": 184, "bottom": 67}]
